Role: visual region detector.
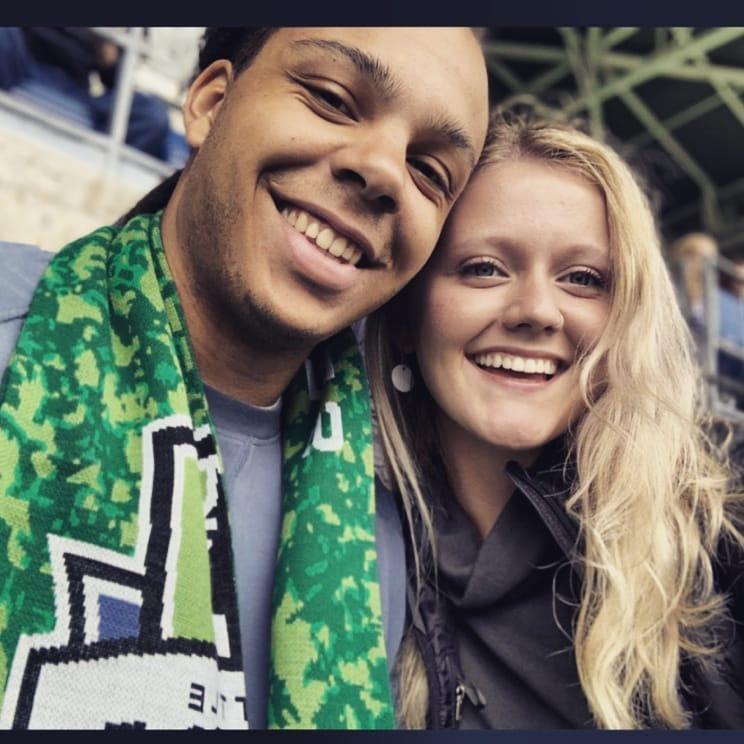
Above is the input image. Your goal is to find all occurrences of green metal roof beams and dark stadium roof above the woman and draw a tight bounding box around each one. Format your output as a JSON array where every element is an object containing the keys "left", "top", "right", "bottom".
[{"left": 484, "top": 27, "right": 744, "bottom": 258}]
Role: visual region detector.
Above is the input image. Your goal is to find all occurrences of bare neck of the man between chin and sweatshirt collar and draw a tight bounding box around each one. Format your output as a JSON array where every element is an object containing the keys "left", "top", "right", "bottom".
[{"left": 161, "top": 200, "right": 311, "bottom": 406}]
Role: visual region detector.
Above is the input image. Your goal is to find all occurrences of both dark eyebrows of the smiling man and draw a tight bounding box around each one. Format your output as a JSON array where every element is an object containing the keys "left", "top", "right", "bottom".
[{"left": 292, "top": 39, "right": 476, "bottom": 165}]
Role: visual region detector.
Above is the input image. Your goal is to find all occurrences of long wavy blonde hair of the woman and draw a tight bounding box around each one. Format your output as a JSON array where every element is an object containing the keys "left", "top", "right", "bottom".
[{"left": 365, "top": 114, "right": 744, "bottom": 729}]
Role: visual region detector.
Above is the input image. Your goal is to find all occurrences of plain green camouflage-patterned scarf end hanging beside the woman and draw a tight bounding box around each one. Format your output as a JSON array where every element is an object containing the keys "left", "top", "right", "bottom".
[{"left": 268, "top": 331, "right": 394, "bottom": 729}]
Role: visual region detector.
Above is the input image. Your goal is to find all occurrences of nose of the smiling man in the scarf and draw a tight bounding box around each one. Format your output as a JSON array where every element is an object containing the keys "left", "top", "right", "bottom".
[{"left": 331, "top": 130, "right": 407, "bottom": 213}]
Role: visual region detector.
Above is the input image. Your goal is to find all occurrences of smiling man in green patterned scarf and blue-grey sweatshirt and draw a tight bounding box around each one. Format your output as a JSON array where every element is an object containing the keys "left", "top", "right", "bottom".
[{"left": 0, "top": 28, "right": 487, "bottom": 728}]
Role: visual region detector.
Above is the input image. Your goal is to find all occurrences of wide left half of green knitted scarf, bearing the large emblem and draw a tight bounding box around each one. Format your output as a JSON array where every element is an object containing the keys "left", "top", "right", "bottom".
[{"left": 0, "top": 215, "right": 245, "bottom": 728}]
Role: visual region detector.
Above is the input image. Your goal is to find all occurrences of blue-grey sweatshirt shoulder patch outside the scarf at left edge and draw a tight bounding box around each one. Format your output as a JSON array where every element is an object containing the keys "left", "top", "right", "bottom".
[{"left": 0, "top": 241, "right": 53, "bottom": 323}]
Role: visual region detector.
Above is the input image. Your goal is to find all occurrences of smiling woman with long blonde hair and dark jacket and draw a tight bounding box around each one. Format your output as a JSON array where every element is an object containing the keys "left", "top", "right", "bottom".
[{"left": 366, "top": 116, "right": 744, "bottom": 728}]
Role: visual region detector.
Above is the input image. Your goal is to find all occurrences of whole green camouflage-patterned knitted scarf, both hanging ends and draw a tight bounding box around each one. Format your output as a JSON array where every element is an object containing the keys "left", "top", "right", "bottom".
[{"left": 0, "top": 209, "right": 393, "bottom": 728}]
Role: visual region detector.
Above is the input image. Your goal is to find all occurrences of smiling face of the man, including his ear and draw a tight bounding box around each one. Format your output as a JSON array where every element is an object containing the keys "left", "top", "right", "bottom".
[{"left": 178, "top": 28, "right": 487, "bottom": 348}]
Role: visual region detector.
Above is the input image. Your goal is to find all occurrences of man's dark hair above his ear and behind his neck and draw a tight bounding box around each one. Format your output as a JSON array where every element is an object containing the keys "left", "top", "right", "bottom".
[{"left": 116, "top": 27, "right": 276, "bottom": 226}]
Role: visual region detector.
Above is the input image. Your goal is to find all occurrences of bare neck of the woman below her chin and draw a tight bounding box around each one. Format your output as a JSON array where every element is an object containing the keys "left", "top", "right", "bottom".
[{"left": 437, "top": 413, "right": 541, "bottom": 538}]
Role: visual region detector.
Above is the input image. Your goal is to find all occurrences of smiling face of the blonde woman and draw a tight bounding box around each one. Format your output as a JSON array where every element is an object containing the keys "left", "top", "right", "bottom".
[{"left": 412, "top": 159, "right": 610, "bottom": 451}]
